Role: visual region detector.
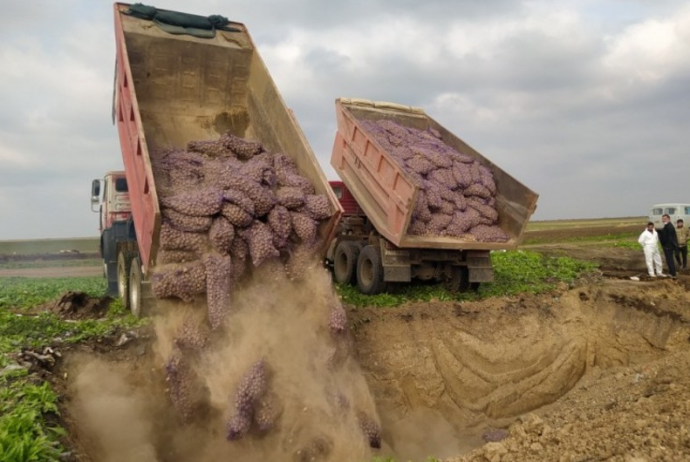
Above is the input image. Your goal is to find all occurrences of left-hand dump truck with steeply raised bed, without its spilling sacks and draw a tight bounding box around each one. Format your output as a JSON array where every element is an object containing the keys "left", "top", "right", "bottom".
[{"left": 91, "top": 3, "right": 342, "bottom": 316}]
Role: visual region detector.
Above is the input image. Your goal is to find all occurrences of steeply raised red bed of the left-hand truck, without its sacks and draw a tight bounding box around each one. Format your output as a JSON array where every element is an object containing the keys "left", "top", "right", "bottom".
[{"left": 114, "top": 3, "right": 342, "bottom": 270}]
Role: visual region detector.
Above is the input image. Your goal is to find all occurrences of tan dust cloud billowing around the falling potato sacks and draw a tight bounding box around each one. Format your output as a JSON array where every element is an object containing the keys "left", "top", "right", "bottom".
[{"left": 64, "top": 265, "right": 380, "bottom": 462}]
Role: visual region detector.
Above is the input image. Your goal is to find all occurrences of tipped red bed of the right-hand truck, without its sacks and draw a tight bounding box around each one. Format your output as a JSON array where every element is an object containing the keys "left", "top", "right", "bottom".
[{"left": 331, "top": 98, "right": 539, "bottom": 250}]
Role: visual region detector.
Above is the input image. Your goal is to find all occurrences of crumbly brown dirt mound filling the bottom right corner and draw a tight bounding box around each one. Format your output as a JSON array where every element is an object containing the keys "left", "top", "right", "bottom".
[{"left": 447, "top": 351, "right": 690, "bottom": 462}]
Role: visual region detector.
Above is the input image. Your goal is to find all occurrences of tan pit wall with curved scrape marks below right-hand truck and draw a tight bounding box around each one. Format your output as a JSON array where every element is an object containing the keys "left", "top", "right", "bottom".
[{"left": 351, "top": 280, "right": 690, "bottom": 460}]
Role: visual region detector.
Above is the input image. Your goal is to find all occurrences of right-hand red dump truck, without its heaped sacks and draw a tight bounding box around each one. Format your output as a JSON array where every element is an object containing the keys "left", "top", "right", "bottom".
[{"left": 327, "top": 98, "right": 538, "bottom": 294}]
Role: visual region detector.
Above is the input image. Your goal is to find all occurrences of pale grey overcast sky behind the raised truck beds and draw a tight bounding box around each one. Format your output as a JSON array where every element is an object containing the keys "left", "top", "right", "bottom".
[{"left": 0, "top": 0, "right": 690, "bottom": 240}]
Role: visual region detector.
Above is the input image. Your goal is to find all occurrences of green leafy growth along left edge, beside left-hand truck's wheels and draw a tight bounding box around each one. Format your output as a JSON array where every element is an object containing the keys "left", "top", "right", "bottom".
[{"left": 0, "top": 278, "right": 146, "bottom": 462}]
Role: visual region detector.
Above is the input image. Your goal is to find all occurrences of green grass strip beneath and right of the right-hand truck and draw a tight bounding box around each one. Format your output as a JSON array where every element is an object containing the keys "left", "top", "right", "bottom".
[{"left": 336, "top": 251, "right": 596, "bottom": 307}]
